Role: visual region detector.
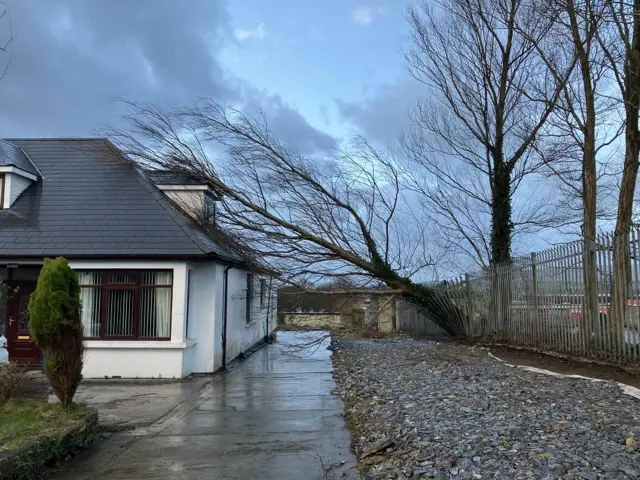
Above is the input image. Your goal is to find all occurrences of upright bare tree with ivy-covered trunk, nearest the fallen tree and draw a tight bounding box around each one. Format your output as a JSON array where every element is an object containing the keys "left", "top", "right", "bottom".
[{"left": 403, "top": 0, "right": 563, "bottom": 266}]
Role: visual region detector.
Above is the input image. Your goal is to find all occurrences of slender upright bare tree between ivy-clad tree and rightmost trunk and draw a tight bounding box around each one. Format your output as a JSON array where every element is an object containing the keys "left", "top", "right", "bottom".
[{"left": 518, "top": 0, "right": 621, "bottom": 344}]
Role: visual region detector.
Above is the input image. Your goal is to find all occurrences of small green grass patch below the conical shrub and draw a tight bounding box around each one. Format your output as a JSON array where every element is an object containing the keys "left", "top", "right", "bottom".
[{"left": 0, "top": 398, "right": 87, "bottom": 451}]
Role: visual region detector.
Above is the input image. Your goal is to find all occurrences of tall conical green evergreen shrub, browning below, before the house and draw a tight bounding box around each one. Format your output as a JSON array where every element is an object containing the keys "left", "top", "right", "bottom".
[{"left": 29, "top": 257, "right": 84, "bottom": 405}]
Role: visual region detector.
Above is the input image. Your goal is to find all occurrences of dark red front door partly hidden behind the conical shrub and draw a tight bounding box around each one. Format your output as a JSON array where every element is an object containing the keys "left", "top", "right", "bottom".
[{"left": 7, "top": 282, "right": 40, "bottom": 364}]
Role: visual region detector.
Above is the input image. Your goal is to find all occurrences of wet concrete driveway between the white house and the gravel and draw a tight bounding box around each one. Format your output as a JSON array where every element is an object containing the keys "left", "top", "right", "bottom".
[{"left": 47, "top": 332, "right": 359, "bottom": 480}]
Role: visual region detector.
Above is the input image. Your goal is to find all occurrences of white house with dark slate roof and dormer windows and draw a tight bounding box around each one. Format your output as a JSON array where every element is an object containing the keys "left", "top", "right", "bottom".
[{"left": 0, "top": 138, "right": 276, "bottom": 378}]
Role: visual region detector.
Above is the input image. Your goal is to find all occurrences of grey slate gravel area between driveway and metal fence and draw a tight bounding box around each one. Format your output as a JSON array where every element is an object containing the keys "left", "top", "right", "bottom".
[{"left": 332, "top": 339, "right": 640, "bottom": 480}]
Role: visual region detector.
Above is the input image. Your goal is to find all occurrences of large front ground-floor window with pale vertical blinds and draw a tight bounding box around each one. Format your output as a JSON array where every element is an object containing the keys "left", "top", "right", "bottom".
[{"left": 78, "top": 270, "right": 173, "bottom": 339}]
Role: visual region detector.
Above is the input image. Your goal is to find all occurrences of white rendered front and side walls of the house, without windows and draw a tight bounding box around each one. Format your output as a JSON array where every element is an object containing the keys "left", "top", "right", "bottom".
[{"left": 69, "top": 260, "right": 276, "bottom": 378}]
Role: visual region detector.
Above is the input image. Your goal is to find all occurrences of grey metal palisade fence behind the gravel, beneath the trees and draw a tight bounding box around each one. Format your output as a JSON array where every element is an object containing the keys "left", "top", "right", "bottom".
[{"left": 397, "top": 228, "right": 640, "bottom": 363}]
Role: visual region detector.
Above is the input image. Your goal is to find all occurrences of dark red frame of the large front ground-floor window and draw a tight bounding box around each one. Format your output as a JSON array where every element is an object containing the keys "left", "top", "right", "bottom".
[{"left": 79, "top": 269, "right": 173, "bottom": 341}]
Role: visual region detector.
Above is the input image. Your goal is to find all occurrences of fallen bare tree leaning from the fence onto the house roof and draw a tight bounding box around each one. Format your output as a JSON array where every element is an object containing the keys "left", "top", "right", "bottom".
[{"left": 110, "top": 98, "right": 464, "bottom": 334}]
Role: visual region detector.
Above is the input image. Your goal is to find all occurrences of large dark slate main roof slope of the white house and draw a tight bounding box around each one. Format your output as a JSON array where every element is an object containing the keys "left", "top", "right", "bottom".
[{"left": 0, "top": 138, "right": 241, "bottom": 262}]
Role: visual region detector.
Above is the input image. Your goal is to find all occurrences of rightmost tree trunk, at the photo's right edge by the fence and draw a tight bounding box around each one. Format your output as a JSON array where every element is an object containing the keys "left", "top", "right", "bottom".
[{"left": 610, "top": 0, "right": 640, "bottom": 360}]
